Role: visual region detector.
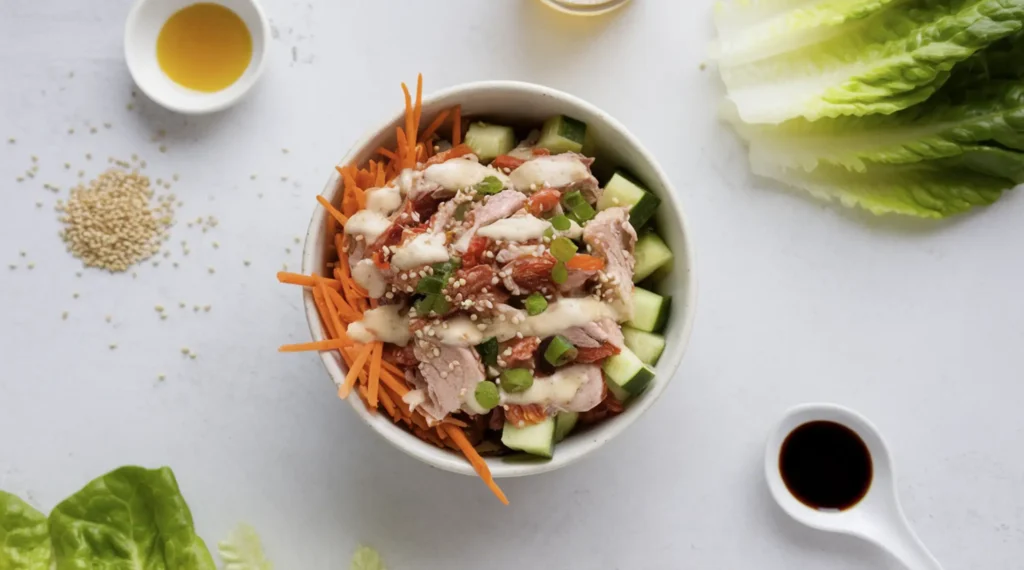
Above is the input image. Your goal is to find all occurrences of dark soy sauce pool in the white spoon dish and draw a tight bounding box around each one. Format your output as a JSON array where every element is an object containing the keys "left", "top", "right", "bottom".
[{"left": 778, "top": 422, "right": 871, "bottom": 511}]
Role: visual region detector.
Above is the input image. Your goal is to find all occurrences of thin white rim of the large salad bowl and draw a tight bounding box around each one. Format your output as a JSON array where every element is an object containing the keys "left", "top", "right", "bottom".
[{"left": 301, "top": 80, "right": 697, "bottom": 479}]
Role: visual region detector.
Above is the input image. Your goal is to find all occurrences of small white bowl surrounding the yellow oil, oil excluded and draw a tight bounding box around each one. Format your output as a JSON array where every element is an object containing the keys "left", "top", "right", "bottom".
[{"left": 125, "top": 0, "right": 270, "bottom": 115}]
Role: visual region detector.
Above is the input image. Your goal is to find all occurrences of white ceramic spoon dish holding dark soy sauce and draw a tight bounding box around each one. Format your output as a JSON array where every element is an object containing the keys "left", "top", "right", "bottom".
[{"left": 765, "top": 403, "right": 942, "bottom": 570}]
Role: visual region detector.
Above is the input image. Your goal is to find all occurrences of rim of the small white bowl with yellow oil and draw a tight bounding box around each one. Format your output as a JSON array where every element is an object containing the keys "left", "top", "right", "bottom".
[{"left": 121, "top": 0, "right": 270, "bottom": 115}]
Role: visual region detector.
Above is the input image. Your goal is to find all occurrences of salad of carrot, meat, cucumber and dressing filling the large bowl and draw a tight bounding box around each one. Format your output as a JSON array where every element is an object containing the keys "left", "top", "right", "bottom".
[{"left": 279, "top": 79, "right": 690, "bottom": 501}]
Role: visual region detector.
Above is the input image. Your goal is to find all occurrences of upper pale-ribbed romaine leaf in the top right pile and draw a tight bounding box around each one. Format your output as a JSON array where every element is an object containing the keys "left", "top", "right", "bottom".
[{"left": 719, "top": 0, "right": 1024, "bottom": 124}]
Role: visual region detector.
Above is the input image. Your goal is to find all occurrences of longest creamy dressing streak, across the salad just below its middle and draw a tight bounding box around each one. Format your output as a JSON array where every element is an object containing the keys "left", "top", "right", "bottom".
[{"left": 434, "top": 297, "right": 622, "bottom": 347}]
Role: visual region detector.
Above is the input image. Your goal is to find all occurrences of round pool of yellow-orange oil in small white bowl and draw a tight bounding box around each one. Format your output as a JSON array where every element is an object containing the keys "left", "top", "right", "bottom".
[{"left": 157, "top": 2, "right": 253, "bottom": 92}]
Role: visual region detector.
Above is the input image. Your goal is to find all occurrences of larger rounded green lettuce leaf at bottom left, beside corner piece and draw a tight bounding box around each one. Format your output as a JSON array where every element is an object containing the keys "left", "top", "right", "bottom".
[{"left": 49, "top": 467, "right": 215, "bottom": 570}]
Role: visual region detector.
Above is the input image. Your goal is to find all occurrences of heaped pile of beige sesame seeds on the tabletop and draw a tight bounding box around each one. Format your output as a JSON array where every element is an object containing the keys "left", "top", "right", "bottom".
[{"left": 57, "top": 169, "right": 174, "bottom": 272}]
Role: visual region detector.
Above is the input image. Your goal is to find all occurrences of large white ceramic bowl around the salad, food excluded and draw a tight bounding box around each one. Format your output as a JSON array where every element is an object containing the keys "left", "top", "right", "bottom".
[{"left": 302, "top": 81, "right": 696, "bottom": 477}]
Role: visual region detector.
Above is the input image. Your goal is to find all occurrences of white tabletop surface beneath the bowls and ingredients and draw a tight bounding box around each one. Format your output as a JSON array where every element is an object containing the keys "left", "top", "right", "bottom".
[{"left": 0, "top": 0, "right": 1024, "bottom": 570}]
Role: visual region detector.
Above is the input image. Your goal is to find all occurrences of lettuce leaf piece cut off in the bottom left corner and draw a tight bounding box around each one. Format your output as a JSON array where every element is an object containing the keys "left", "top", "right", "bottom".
[{"left": 0, "top": 491, "right": 51, "bottom": 570}]
